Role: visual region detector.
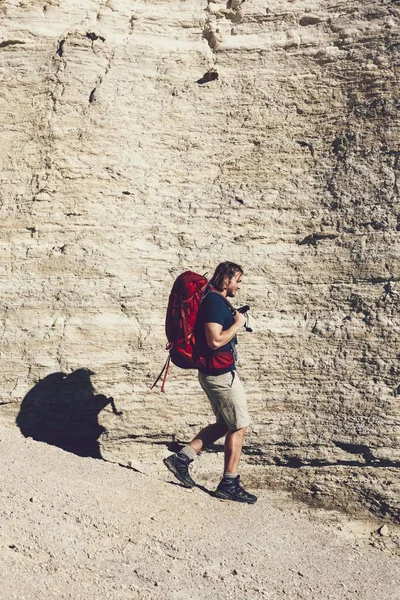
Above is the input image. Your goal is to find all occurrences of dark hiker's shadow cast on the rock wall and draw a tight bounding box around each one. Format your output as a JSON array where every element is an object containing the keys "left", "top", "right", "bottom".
[{"left": 16, "top": 369, "right": 122, "bottom": 458}]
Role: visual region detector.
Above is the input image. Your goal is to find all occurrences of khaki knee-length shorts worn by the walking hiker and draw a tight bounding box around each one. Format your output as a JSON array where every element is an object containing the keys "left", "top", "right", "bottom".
[{"left": 199, "top": 371, "right": 251, "bottom": 431}]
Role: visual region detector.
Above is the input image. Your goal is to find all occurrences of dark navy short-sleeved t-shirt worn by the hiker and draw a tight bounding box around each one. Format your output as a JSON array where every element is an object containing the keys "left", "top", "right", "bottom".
[{"left": 196, "top": 292, "right": 236, "bottom": 375}]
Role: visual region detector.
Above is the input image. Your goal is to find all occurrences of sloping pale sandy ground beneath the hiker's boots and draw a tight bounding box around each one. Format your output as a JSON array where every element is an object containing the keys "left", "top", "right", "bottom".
[{"left": 0, "top": 429, "right": 400, "bottom": 600}]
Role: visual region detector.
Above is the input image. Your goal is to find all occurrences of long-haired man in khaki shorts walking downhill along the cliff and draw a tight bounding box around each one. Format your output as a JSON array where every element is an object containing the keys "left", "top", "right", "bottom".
[{"left": 164, "top": 262, "right": 257, "bottom": 504}]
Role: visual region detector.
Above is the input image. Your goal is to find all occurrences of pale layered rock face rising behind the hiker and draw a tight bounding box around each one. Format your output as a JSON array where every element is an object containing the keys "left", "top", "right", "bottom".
[{"left": 0, "top": 0, "right": 400, "bottom": 518}]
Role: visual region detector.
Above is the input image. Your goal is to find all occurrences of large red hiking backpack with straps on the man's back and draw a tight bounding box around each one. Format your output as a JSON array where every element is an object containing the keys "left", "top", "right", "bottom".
[{"left": 151, "top": 271, "right": 234, "bottom": 392}]
